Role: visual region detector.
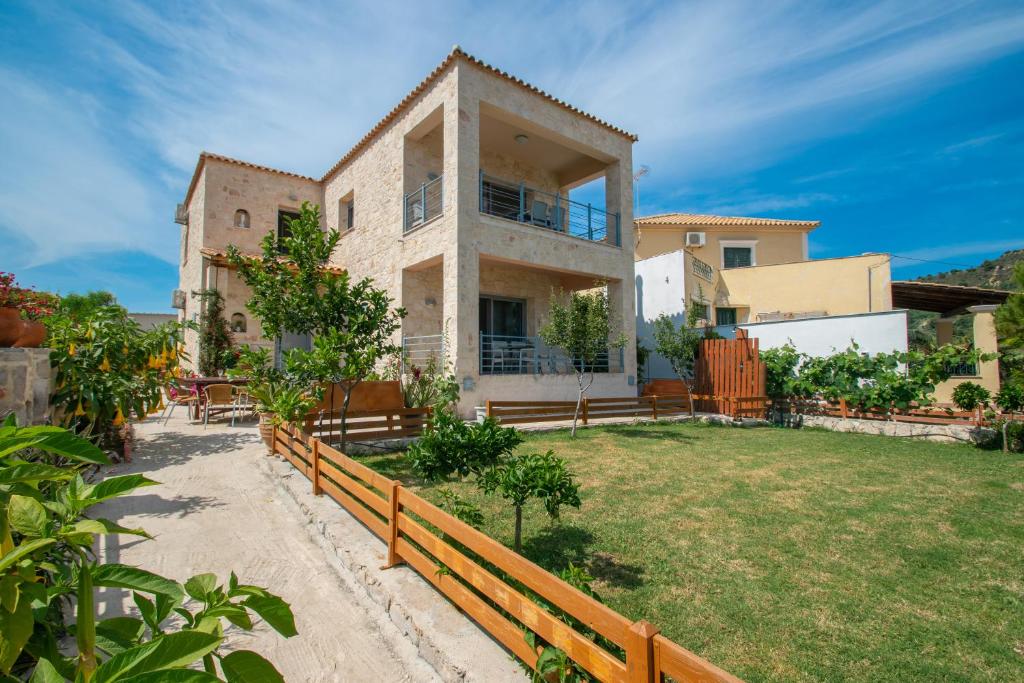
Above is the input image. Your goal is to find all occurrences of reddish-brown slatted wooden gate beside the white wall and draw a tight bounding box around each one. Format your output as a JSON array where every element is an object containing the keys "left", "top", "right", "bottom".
[{"left": 693, "top": 330, "right": 768, "bottom": 418}]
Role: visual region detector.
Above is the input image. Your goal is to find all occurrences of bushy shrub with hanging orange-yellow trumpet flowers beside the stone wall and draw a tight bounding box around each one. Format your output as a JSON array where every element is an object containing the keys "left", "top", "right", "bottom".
[{"left": 46, "top": 306, "right": 191, "bottom": 450}]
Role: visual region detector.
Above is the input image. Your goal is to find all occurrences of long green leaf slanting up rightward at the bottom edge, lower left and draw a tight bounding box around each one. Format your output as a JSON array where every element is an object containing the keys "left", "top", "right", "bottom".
[{"left": 92, "top": 631, "right": 221, "bottom": 683}]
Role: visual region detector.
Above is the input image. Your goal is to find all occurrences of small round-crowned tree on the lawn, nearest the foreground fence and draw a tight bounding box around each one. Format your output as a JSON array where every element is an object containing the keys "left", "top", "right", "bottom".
[{"left": 479, "top": 451, "right": 581, "bottom": 553}]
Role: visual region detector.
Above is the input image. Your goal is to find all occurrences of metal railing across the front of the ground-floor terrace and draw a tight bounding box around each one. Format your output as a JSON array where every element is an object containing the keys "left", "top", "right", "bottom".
[{"left": 480, "top": 333, "right": 624, "bottom": 375}]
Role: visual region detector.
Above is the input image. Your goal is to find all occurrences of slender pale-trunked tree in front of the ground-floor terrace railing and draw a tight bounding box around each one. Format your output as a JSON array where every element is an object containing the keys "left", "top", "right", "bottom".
[{"left": 540, "top": 287, "right": 627, "bottom": 436}]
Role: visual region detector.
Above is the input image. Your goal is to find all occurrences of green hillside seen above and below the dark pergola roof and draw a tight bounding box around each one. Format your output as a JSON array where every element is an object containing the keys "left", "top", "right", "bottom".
[{"left": 907, "top": 249, "right": 1024, "bottom": 350}]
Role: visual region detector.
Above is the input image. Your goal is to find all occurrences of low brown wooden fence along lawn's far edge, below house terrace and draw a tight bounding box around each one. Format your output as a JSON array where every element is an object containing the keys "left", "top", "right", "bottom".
[{"left": 486, "top": 394, "right": 768, "bottom": 424}]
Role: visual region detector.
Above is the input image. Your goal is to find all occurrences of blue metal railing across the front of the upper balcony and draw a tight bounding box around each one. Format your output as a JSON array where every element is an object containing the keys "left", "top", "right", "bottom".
[{"left": 480, "top": 171, "right": 622, "bottom": 247}]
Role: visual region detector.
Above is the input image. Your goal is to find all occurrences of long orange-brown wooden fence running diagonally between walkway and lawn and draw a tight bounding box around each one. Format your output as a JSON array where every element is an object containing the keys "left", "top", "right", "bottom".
[{"left": 272, "top": 424, "right": 738, "bottom": 683}]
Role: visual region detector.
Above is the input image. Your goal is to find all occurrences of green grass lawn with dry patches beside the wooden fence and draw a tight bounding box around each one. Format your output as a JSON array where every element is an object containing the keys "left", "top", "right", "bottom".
[{"left": 367, "top": 424, "right": 1024, "bottom": 681}]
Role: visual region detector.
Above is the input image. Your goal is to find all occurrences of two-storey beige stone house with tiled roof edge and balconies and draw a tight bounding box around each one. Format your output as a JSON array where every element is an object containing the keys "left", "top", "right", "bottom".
[{"left": 175, "top": 47, "right": 636, "bottom": 415}]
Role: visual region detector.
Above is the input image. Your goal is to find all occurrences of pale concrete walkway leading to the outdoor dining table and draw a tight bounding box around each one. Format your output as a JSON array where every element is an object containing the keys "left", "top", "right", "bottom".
[{"left": 96, "top": 417, "right": 441, "bottom": 681}]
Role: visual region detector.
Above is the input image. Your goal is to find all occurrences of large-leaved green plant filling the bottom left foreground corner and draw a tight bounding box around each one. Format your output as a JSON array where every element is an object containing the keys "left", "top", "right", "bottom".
[{"left": 0, "top": 419, "right": 296, "bottom": 683}]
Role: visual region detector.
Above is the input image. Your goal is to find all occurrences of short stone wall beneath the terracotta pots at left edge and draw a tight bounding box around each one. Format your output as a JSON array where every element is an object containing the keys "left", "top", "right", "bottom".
[{"left": 0, "top": 348, "right": 53, "bottom": 425}]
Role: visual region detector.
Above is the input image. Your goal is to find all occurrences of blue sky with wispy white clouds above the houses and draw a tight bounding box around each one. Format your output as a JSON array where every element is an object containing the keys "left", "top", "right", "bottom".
[{"left": 0, "top": 0, "right": 1024, "bottom": 310}]
